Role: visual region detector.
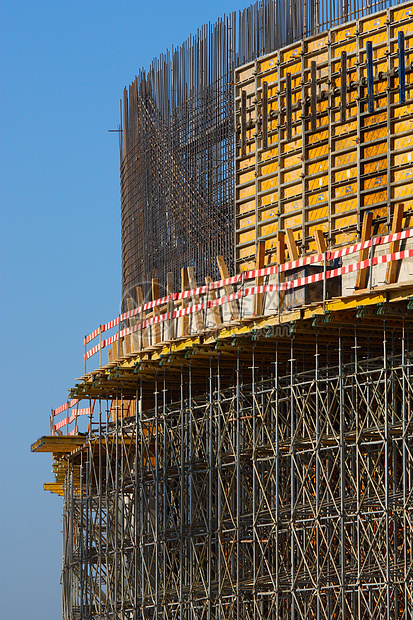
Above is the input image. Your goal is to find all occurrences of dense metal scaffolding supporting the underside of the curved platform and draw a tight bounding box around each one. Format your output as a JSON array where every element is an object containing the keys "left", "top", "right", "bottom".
[{"left": 58, "top": 302, "right": 413, "bottom": 620}]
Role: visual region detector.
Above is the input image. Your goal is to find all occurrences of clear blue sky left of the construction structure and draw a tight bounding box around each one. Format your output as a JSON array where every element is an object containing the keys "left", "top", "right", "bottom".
[{"left": 0, "top": 0, "right": 243, "bottom": 620}]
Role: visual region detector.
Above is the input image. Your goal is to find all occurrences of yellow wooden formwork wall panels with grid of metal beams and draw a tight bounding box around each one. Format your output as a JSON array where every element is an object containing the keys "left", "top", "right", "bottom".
[{"left": 235, "top": 2, "right": 413, "bottom": 271}]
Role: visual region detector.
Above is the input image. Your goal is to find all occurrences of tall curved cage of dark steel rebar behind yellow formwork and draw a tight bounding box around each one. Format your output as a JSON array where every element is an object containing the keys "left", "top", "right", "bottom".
[{"left": 121, "top": 0, "right": 406, "bottom": 300}]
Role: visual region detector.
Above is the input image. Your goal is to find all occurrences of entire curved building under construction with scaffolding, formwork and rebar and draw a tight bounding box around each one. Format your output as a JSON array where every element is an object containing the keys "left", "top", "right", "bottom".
[{"left": 31, "top": 0, "right": 413, "bottom": 620}]
